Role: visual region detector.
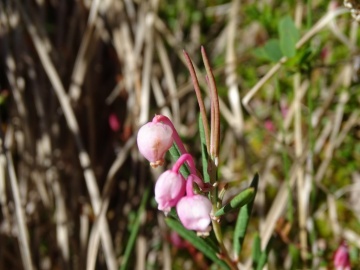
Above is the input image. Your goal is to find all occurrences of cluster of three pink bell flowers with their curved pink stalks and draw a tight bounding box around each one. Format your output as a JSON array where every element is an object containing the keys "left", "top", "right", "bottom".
[{"left": 137, "top": 115, "right": 212, "bottom": 235}]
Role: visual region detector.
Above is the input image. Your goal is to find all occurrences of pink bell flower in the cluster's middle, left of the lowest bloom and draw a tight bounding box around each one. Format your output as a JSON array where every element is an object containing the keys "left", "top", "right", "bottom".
[{"left": 155, "top": 170, "right": 185, "bottom": 215}]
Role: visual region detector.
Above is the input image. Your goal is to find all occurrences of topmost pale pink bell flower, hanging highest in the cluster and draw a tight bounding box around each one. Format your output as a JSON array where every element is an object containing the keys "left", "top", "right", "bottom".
[{"left": 137, "top": 122, "right": 173, "bottom": 168}]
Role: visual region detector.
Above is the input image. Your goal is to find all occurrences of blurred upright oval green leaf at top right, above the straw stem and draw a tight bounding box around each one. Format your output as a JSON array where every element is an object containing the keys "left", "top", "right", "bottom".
[{"left": 278, "top": 16, "right": 300, "bottom": 58}]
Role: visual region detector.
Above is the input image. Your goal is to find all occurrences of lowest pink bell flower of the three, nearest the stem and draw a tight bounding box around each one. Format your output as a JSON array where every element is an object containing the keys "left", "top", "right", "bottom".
[{"left": 176, "top": 194, "right": 212, "bottom": 235}]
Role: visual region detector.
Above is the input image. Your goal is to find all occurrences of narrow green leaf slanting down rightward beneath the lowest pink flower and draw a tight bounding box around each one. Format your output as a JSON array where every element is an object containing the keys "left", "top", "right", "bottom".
[{"left": 165, "top": 218, "right": 230, "bottom": 269}]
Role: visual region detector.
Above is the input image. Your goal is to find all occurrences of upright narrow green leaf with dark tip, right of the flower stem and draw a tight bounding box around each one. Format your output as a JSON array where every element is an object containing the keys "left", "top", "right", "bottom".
[{"left": 233, "top": 173, "right": 259, "bottom": 256}]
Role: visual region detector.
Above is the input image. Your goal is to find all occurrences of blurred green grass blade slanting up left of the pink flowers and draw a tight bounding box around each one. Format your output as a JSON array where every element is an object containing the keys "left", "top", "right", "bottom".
[{"left": 120, "top": 188, "right": 150, "bottom": 270}]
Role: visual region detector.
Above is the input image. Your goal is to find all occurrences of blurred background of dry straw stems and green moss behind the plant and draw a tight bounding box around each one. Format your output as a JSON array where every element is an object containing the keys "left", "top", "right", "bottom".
[{"left": 0, "top": 0, "right": 360, "bottom": 269}]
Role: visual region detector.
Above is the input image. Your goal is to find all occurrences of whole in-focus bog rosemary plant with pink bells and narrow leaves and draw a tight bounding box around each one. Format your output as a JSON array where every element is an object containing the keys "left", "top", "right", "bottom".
[{"left": 137, "top": 47, "right": 267, "bottom": 269}]
